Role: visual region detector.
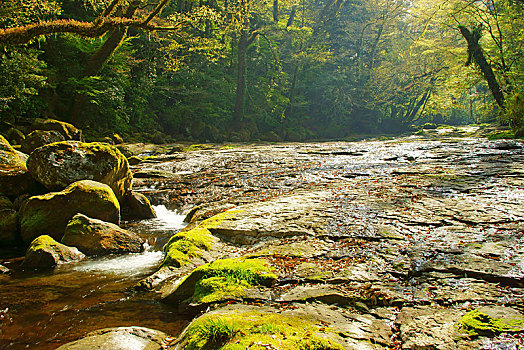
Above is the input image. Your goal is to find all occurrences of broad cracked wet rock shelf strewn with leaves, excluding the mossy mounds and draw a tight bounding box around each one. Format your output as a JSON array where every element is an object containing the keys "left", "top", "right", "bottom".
[{"left": 130, "top": 133, "right": 524, "bottom": 349}]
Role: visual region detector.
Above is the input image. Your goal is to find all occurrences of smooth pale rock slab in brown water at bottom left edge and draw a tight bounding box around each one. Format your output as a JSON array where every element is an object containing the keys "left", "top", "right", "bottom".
[{"left": 58, "top": 327, "right": 170, "bottom": 350}]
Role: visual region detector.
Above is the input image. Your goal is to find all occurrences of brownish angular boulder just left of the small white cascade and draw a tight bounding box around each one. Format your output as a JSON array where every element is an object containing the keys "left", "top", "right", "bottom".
[{"left": 62, "top": 214, "right": 144, "bottom": 255}]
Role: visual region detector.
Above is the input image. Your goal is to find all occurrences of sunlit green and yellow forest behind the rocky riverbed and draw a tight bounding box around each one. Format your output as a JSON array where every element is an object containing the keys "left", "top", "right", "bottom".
[{"left": 0, "top": 0, "right": 524, "bottom": 142}]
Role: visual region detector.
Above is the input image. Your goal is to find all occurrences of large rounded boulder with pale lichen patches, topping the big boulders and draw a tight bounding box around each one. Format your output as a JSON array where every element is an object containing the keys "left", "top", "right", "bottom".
[{"left": 27, "top": 141, "right": 133, "bottom": 200}]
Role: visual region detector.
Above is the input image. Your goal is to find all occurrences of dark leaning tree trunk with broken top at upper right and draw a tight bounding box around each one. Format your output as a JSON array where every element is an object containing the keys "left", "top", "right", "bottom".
[{"left": 459, "top": 26, "right": 504, "bottom": 109}]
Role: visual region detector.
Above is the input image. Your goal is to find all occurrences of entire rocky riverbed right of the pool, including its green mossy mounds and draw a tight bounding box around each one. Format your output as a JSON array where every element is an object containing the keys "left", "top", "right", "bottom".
[{"left": 0, "top": 127, "right": 524, "bottom": 350}]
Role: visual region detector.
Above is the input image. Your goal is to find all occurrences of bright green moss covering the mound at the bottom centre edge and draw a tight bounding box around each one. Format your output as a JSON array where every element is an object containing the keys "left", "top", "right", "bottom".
[{"left": 183, "top": 312, "right": 343, "bottom": 350}]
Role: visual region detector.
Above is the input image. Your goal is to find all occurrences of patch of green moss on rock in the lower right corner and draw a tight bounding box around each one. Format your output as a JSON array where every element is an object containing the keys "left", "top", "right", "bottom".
[{"left": 459, "top": 309, "right": 524, "bottom": 335}]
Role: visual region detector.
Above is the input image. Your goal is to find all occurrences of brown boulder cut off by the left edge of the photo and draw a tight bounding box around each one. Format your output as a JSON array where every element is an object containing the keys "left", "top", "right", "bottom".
[{"left": 0, "top": 135, "right": 35, "bottom": 197}]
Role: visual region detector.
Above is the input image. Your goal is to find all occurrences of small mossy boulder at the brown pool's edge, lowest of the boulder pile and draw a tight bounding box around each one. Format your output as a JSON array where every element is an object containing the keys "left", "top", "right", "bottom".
[{"left": 22, "top": 235, "right": 85, "bottom": 268}]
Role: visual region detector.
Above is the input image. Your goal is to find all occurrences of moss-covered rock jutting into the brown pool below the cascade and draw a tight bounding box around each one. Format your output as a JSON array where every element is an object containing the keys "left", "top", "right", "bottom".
[{"left": 165, "top": 258, "right": 277, "bottom": 305}]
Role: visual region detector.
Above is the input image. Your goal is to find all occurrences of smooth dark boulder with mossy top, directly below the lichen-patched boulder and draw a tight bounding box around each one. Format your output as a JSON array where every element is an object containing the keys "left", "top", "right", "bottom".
[{"left": 20, "top": 180, "right": 120, "bottom": 243}]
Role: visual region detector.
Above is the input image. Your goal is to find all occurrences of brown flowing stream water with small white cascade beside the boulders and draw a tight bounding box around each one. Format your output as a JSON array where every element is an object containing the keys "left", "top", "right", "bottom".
[{"left": 0, "top": 206, "right": 187, "bottom": 349}]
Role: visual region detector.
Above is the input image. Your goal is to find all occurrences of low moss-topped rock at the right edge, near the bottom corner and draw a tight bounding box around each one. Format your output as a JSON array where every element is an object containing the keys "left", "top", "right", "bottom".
[{"left": 459, "top": 306, "right": 524, "bottom": 336}]
